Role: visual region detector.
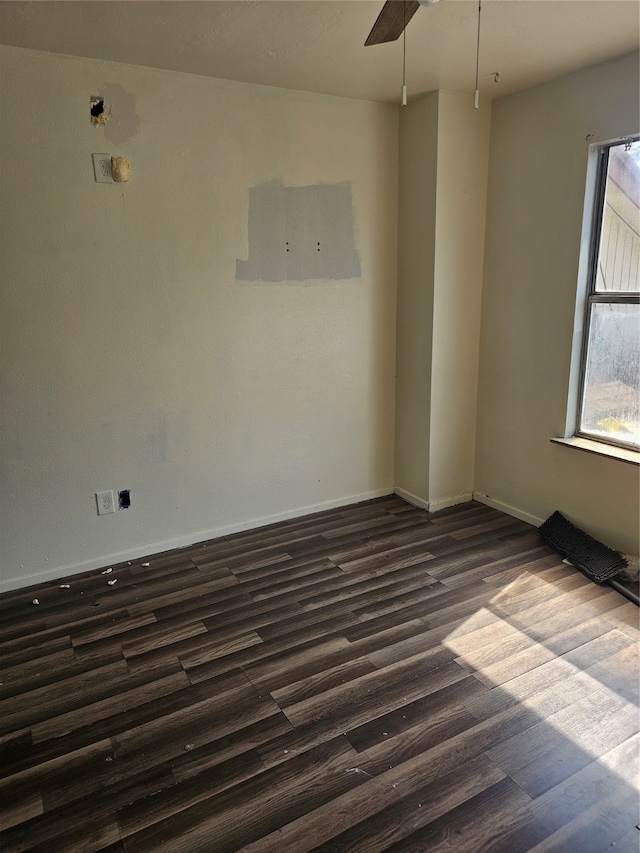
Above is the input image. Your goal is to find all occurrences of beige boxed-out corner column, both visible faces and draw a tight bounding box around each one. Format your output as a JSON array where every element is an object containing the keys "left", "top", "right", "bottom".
[{"left": 395, "top": 91, "right": 491, "bottom": 510}]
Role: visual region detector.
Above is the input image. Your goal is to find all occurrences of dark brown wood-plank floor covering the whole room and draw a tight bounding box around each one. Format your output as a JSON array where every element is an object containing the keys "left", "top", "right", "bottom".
[{"left": 0, "top": 496, "right": 640, "bottom": 853}]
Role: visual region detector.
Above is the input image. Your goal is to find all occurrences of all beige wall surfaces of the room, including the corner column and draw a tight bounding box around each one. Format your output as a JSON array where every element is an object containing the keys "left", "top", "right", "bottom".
[{"left": 0, "top": 43, "right": 639, "bottom": 589}]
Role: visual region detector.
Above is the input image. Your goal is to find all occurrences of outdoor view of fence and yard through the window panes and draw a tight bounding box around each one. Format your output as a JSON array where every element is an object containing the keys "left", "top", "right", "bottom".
[{"left": 580, "top": 140, "right": 640, "bottom": 448}]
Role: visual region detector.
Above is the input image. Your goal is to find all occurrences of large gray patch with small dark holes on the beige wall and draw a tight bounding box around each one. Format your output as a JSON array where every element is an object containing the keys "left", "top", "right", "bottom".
[{"left": 236, "top": 181, "right": 360, "bottom": 281}]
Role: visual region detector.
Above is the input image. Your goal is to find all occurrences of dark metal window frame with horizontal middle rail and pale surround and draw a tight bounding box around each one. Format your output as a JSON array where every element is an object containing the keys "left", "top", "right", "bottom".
[{"left": 573, "top": 135, "right": 640, "bottom": 453}]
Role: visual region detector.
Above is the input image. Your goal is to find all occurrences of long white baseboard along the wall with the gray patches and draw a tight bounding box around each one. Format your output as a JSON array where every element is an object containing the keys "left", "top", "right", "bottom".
[{"left": 0, "top": 486, "right": 394, "bottom": 593}]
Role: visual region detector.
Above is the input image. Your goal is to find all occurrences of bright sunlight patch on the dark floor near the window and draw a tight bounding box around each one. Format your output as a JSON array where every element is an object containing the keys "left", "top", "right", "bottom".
[{"left": 443, "top": 575, "right": 640, "bottom": 786}]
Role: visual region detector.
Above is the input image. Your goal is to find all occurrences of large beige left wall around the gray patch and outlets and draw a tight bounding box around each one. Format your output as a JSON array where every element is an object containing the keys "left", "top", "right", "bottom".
[{"left": 0, "top": 48, "right": 397, "bottom": 588}]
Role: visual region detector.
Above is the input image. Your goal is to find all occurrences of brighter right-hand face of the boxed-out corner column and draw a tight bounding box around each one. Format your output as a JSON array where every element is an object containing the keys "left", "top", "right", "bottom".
[{"left": 429, "top": 92, "right": 491, "bottom": 509}]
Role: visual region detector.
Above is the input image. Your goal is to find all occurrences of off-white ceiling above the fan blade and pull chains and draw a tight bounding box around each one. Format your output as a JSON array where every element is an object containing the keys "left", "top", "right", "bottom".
[{"left": 0, "top": 0, "right": 640, "bottom": 102}]
